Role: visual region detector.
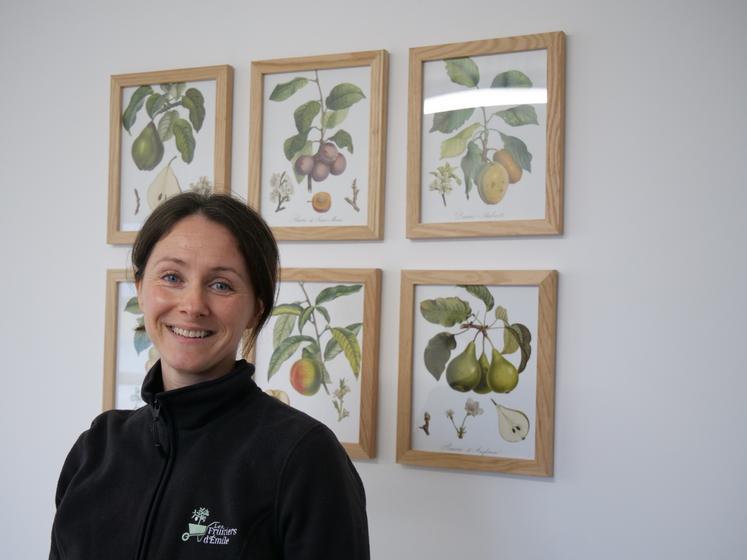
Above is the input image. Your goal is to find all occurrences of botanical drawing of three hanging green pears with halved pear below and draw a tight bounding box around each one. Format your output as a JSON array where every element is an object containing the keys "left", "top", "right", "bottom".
[{"left": 416, "top": 285, "right": 532, "bottom": 443}]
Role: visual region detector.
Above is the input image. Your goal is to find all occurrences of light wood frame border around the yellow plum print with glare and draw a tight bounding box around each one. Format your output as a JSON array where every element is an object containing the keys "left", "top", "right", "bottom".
[{"left": 407, "top": 32, "right": 565, "bottom": 239}]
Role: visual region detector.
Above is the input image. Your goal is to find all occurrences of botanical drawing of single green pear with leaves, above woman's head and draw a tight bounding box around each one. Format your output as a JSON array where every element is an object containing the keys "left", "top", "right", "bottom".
[{"left": 121, "top": 82, "right": 212, "bottom": 215}]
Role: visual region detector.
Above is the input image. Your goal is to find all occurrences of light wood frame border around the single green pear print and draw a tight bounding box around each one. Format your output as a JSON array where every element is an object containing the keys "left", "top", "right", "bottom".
[{"left": 106, "top": 65, "right": 233, "bottom": 244}]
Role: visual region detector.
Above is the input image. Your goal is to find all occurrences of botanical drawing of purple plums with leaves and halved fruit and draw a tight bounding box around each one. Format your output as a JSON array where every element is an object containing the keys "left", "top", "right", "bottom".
[{"left": 269, "top": 70, "right": 366, "bottom": 214}]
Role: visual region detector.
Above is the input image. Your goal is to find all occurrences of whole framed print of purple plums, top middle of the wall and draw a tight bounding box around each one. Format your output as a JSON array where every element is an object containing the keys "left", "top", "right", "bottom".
[{"left": 249, "top": 50, "right": 389, "bottom": 241}]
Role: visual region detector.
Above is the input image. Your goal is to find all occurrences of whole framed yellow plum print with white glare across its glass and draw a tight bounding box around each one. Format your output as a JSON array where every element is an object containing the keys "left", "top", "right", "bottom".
[{"left": 407, "top": 32, "right": 565, "bottom": 239}]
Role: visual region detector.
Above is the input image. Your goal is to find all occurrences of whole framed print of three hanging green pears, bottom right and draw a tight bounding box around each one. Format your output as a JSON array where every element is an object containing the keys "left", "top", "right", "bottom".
[{"left": 397, "top": 270, "right": 558, "bottom": 476}]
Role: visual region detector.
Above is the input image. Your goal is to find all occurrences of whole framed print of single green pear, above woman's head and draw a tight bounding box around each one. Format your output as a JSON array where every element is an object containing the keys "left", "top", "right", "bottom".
[{"left": 106, "top": 65, "right": 233, "bottom": 244}]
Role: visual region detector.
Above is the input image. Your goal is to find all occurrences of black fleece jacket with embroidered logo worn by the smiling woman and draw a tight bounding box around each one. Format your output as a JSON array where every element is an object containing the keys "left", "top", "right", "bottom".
[{"left": 49, "top": 360, "right": 369, "bottom": 560}]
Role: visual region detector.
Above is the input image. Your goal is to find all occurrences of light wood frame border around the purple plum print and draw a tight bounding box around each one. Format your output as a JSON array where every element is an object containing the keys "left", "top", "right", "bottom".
[{"left": 249, "top": 50, "right": 389, "bottom": 241}]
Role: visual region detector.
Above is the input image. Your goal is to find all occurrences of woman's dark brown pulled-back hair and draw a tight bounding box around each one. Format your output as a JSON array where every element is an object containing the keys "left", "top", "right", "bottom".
[{"left": 132, "top": 192, "right": 280, "bottom": 356}]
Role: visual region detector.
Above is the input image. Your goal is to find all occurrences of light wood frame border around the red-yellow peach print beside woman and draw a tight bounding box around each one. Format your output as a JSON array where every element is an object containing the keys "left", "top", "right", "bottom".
[{"left": 250, "top": 268, "right": 381, "bottom": 459}]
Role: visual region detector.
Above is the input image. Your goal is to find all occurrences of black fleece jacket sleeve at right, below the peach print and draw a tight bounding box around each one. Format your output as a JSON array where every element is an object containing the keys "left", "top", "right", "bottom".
[{"left": 276, "top": 425, "right": 370, "bottom": 560}]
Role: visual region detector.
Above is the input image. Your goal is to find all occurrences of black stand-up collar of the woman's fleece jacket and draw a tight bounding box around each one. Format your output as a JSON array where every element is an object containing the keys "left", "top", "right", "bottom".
[{"left": 141, "top": 360, "right": 260, "bottom": 429}]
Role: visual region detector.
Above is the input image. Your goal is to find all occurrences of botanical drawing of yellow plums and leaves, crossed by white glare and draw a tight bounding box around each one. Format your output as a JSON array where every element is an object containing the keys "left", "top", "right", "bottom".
[{"left": 428, "top": 58, "right": 539, "bottom": 206}]
